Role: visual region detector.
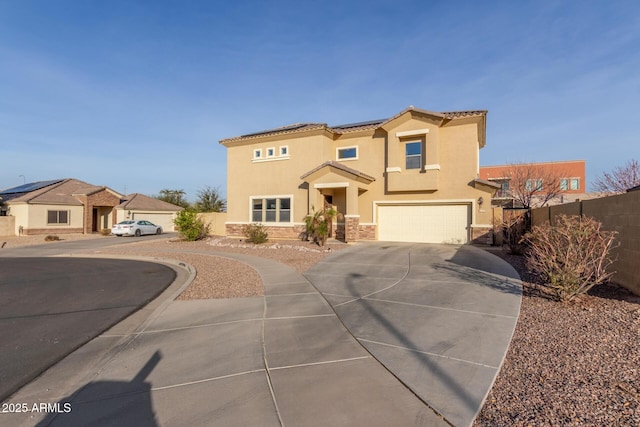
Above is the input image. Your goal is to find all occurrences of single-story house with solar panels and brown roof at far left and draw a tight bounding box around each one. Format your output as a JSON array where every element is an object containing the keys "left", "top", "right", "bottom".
[{"left": 0, "top": 179, "right": 182, "bottom": 235}]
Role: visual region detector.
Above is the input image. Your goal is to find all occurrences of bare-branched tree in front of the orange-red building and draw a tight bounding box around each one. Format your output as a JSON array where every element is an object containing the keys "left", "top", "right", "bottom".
[{"left": 504, "top": 163, "right": 566, "bottom": 208}]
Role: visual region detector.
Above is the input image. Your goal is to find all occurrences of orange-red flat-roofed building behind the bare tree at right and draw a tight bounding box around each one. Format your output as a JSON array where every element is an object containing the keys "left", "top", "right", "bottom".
[{"left": 480, "top": 160, "right": 589, "bottom": 207}]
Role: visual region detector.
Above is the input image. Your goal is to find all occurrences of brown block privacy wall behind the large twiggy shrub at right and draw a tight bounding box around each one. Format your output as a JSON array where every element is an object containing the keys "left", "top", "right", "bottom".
[{"left": 532, "top": 191, "right": 640, "bottom": 295}]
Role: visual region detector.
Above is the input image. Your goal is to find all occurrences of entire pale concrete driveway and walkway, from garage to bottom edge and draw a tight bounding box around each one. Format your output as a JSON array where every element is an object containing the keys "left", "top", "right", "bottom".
[{"left": 0, "top": 243, "right": 520, "bottom": 427}]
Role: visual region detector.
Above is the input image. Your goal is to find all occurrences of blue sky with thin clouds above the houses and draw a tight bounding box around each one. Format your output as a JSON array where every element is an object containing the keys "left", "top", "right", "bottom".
[{"left": 0, "top": 0, "right": 640, "bottom": 200}]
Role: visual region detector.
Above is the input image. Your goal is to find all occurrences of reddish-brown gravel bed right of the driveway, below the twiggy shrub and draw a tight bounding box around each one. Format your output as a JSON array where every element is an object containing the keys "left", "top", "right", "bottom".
[{"left": 474, "top": 251, "right": 640, "bottom": 426}]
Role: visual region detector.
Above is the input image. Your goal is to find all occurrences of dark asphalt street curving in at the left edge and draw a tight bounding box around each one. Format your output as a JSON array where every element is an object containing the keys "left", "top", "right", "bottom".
[{"left": 0, "top": 256, "right": 176, "bottom": 401}]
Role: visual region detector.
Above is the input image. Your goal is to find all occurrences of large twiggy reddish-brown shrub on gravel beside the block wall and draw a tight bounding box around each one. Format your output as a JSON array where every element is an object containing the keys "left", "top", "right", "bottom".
[{"left": 524, "top": 215, "right": 617, "bottom": 301}]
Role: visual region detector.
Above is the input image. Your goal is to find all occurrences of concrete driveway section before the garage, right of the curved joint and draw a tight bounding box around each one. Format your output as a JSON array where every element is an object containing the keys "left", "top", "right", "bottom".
[{"left": 305, "top": 242, "right": 522, "bottom": 426}]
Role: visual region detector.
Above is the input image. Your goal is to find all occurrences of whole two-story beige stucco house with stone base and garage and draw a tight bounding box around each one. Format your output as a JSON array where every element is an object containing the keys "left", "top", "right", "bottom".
[{"left": 220, "top": 107, "right": 500, "bottom": 243}]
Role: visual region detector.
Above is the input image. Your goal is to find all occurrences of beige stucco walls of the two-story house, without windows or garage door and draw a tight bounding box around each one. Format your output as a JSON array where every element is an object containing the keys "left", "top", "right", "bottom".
[{"left": 222, "top": 113, "right": 492, "bottom": 241}]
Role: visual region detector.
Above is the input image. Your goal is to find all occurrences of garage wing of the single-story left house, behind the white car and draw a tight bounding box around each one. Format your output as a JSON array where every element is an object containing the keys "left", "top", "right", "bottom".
[{"left": 115, "top": 193, "right": 183, "bottom": 231}]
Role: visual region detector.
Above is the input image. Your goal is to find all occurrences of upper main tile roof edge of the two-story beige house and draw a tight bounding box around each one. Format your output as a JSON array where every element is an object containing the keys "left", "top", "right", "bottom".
[{"left": 220, "top": 106, "right": 487, "bottom": 145}]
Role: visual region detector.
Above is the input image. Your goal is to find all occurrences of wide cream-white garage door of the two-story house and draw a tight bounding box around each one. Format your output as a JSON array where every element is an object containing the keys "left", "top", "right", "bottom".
[{"left": 378, "top": 205, "right": 470, "bottom": 244}]
